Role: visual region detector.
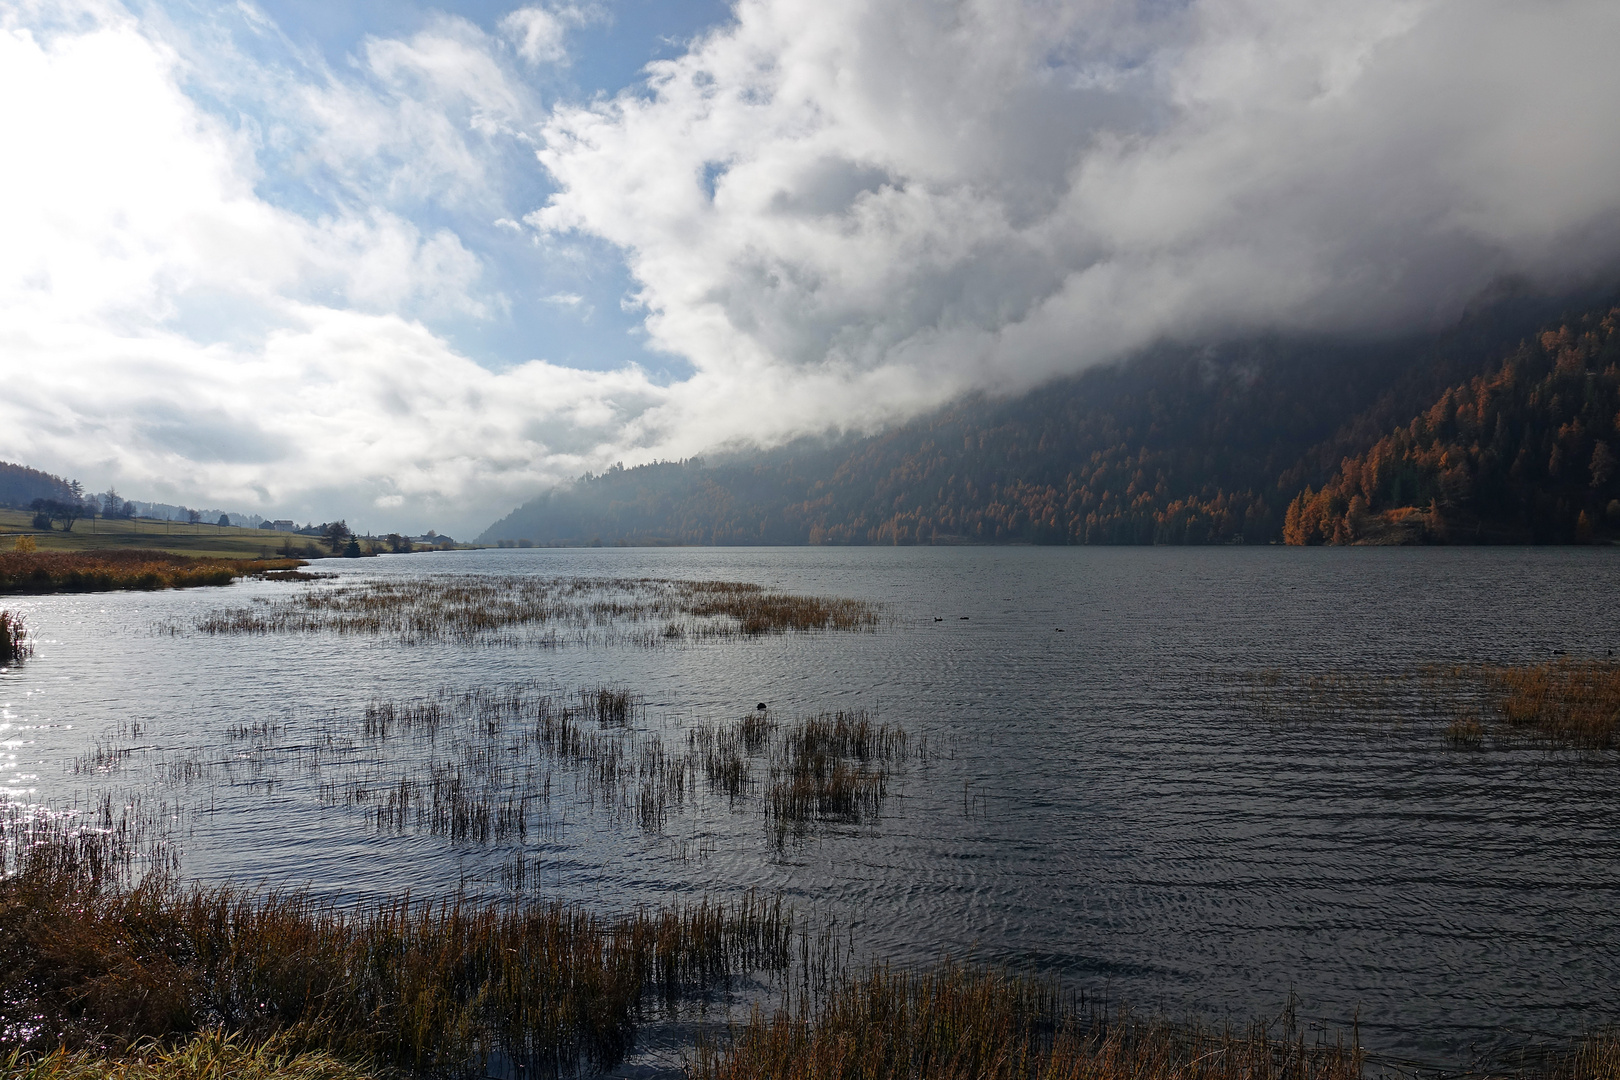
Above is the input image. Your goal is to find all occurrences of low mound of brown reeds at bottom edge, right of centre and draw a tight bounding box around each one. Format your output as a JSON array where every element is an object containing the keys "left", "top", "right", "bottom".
[{"left": 692, "top": 962, "right": 1364, "bottom": 1080}]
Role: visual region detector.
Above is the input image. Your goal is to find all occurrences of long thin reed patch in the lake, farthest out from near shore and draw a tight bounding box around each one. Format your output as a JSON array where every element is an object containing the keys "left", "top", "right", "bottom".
[{"left": 193, "top": 575, "right": 883, "bottom": 646}]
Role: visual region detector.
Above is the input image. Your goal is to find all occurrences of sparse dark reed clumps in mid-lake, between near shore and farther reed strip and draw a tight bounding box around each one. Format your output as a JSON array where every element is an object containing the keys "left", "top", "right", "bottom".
[{"left": 311, "top": 683, "right": 927, "bottom": 848}]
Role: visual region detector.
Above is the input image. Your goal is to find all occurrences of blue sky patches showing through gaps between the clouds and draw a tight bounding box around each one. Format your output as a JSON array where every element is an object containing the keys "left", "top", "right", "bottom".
[{"left": 169, "top": 0, "right": 731, "bottom": 382}]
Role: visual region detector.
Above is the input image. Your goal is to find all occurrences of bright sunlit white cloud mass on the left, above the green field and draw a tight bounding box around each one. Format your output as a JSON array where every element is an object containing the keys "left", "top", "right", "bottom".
[{"left": 0, "top": 5, "right": 644, "bottom": 531}]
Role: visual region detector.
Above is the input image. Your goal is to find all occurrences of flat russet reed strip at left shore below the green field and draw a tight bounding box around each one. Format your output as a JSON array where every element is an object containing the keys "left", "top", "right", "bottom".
[{"left": 0, "top": 547, "right": 305, "bottom": 593}]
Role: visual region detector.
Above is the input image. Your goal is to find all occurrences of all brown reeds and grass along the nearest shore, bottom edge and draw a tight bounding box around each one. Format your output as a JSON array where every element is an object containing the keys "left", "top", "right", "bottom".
[{"left": 0, "top": 824, "right": 1620, "bottom": 1080}]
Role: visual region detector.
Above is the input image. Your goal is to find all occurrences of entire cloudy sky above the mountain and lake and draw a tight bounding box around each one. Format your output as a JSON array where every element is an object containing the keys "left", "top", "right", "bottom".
[{"left": 0, "top": 0, "right": 1620, "bottom": 536}]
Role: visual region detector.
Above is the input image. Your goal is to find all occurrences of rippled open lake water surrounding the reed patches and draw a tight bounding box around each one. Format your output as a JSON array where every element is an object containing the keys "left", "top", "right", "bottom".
[{"left": 0, "top": 547, "right": 1620, "bottom": 1067}]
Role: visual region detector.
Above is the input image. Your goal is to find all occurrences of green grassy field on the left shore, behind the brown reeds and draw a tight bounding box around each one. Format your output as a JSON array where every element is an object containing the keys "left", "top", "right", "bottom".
[{"left": 0, "top": 508, "right": 306, "bottom": 559}]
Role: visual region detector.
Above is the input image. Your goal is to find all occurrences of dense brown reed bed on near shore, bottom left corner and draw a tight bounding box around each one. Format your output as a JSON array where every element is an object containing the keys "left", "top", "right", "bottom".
[{"left": 0, "top": 842, "right": 792, "bottom": 1075}]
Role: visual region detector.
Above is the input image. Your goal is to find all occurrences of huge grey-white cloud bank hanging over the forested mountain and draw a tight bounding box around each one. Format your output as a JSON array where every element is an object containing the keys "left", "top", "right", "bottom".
[{"left": 528, "top": 0, "right": 1620, "bottom": 417}]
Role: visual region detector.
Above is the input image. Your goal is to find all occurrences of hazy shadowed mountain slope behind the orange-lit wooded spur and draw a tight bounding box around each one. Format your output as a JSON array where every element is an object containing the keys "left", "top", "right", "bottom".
[{"left": 481, "top": 293, "right": 1607, "bottom": 544}]
